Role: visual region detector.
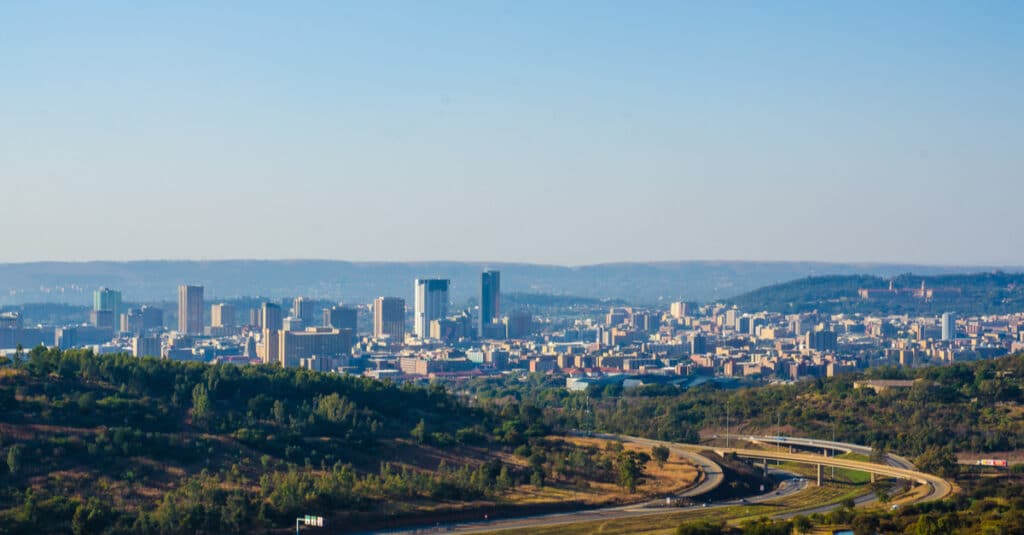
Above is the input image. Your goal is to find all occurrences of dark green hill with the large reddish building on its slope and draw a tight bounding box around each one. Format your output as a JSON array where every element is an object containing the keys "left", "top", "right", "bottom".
[{"left": 727, "top": 272, "right": 1024, "bottom": 315}]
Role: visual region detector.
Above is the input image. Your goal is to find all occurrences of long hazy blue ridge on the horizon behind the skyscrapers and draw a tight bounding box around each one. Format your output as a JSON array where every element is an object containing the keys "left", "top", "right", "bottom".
[{"left": 0, "top": 260, "right": 1007, "bottom": 304}]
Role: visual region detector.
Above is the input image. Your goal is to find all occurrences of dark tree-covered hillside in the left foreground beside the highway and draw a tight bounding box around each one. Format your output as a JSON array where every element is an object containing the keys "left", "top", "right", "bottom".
[{"left": 0, "top": 348, "right": 546, "bottom": 533}]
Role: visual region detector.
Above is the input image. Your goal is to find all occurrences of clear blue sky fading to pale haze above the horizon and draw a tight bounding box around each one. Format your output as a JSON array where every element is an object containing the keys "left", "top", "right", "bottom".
[{"left": 0, "top": 0, "right": 1024, "bottom": 265}]
